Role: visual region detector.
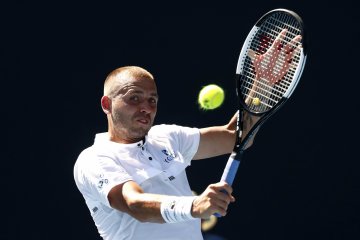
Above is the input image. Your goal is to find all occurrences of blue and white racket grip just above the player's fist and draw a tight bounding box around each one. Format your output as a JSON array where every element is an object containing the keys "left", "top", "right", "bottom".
[{"left": 214, "top": 151, "right": 243, "bottom": 217}]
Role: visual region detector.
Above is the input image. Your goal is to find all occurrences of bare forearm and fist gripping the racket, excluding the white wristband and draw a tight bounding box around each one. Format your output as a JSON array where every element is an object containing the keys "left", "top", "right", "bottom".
[{"left": 108, "top": 181, "right": 235, "bottom": 223}]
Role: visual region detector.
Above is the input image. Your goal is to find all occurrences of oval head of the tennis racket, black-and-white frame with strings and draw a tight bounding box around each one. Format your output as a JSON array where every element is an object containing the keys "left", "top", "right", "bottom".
[{"left": 236, "top": 9, "right": 307, "bottom": 115}]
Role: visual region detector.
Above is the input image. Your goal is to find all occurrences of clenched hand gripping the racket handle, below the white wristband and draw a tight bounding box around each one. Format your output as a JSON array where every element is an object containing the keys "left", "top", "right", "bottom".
[{"left": 192, "top": 182, "right": 235, "bottom": 219}]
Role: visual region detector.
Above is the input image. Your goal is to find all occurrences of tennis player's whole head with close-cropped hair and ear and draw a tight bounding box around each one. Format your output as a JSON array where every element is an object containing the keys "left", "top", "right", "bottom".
[{"left": 101, "top": 66, "right": 158, "bottom": 143}]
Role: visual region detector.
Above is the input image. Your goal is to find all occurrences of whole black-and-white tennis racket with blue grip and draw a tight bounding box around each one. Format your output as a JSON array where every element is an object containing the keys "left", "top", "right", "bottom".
[{"left": 215, "top": 9, "right": 306, "bottom": 217}]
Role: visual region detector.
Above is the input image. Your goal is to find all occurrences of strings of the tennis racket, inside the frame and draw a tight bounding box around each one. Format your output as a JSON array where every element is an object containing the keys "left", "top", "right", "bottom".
[{"left": 240, "top": 13, "right": 301, "bottom": 112}]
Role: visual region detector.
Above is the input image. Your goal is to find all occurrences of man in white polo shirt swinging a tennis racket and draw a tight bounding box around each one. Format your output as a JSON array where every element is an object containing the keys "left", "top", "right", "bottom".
[{"left": 74, "top": 66, "right": 256, "bottom": 240}]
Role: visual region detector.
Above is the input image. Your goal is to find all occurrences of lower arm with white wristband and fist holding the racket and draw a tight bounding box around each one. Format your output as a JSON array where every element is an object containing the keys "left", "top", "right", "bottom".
[{"left": 108, "top": 181, "right": 235, "bottom": 223}]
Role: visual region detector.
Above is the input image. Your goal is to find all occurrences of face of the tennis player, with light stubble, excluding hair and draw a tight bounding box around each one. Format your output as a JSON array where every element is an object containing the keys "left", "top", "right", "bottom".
[{"left": 104, "top": 77, "right": 158, "bottom": 143}]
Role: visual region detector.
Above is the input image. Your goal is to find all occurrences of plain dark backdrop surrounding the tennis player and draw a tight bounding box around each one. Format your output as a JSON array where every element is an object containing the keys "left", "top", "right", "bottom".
[{"left": 0, "top": 0, "right": 360, "bottom": 240}]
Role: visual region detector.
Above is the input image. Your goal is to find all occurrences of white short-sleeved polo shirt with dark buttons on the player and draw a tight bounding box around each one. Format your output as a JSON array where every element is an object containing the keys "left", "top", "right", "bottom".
[{"left": 74, "top": 125, "right": 203, "bottom": 240}]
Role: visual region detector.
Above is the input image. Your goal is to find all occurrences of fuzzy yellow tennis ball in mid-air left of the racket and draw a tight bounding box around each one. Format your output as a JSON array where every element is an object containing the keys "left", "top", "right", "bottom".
[{"left": 198, "top": 84, "right": 225, "bottom": 110}]
